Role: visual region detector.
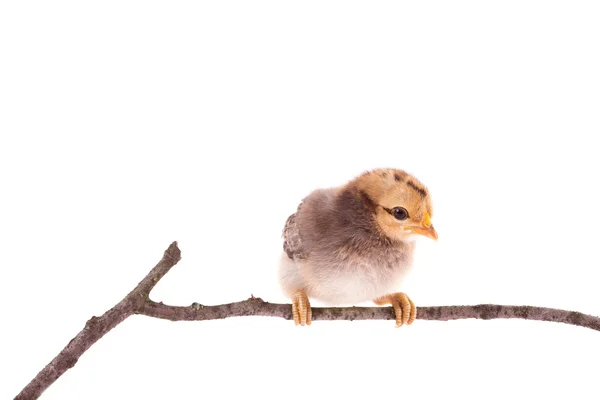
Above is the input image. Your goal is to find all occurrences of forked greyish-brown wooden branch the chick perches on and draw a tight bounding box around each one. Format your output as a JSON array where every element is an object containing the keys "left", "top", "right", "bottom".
[{"left": 15, "top": 242, "right": 600, "bottom": 400}]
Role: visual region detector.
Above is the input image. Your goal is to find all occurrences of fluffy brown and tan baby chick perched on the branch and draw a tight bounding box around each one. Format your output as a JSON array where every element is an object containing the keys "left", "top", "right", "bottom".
[{"left": 279, "top": 169, "right": 437, "bottom": 327}]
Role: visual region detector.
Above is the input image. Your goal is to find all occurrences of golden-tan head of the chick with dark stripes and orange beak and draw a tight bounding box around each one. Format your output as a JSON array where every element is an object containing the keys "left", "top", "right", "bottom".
[{"left": 352, "top": 169, "right": 437, "bottom": 241}]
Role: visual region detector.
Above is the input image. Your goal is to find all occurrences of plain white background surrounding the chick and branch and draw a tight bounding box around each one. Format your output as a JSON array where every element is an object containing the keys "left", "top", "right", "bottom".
[{"left": 0, "top": 1, "right": 600, "bottom": 399}]
